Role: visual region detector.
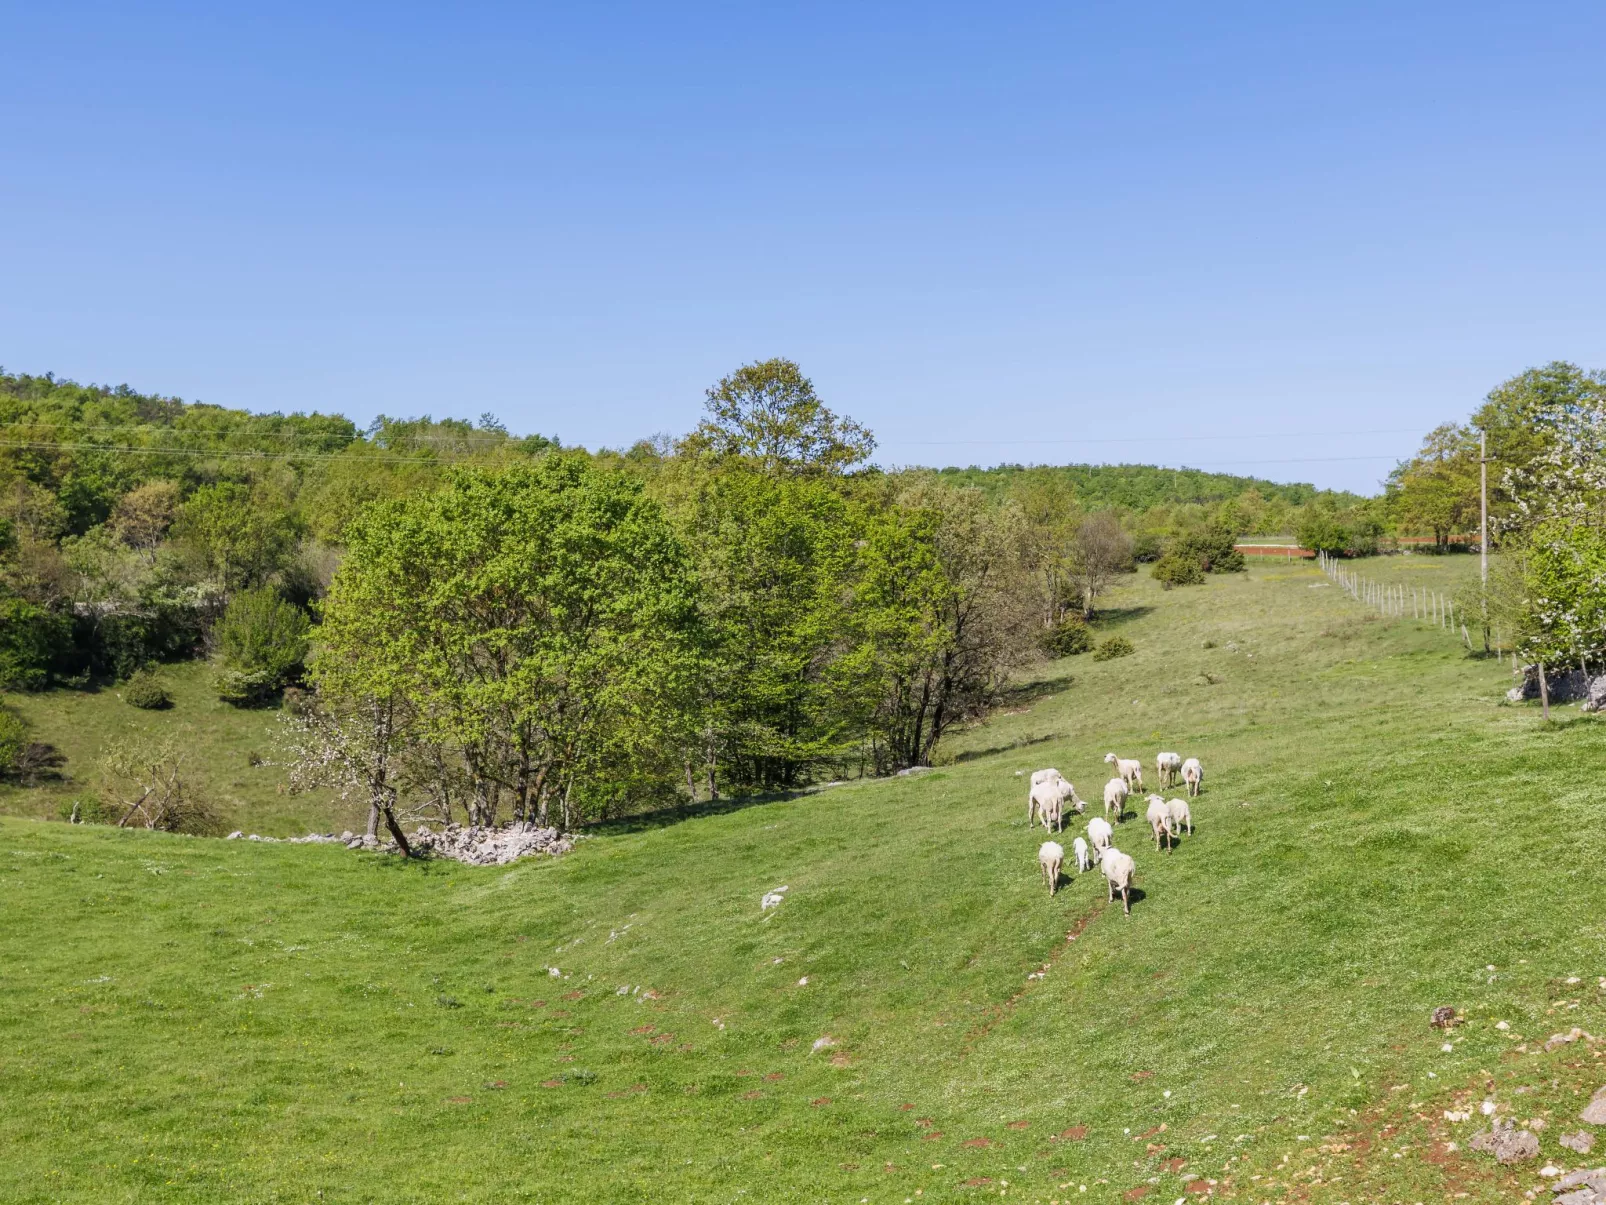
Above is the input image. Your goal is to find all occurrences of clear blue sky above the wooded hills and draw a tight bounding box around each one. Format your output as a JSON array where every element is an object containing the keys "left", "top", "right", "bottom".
[{"left": 0, "top": 0, "right": 1606, "bottom": 490}]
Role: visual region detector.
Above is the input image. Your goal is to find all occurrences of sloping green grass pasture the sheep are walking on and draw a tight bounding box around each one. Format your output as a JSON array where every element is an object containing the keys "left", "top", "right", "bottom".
[{"left": 0, "top": 558, "right": 1606, "bottom": 1205}]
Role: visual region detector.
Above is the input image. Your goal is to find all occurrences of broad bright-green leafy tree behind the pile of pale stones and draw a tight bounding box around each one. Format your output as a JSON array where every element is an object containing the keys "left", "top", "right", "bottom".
[{"left": 313, "top": 455, "right": 699, "bottom": 824}]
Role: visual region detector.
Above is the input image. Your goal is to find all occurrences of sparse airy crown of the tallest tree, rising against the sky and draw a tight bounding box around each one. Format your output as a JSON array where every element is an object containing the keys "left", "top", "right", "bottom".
[{"left": 687, "top": 358, "right": 875, "bottom": 472}]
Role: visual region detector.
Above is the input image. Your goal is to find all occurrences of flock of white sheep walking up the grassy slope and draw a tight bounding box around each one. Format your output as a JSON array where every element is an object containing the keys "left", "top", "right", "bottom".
[{"left": 1026, "top": 752, "right": 1205, "bottom": 916}]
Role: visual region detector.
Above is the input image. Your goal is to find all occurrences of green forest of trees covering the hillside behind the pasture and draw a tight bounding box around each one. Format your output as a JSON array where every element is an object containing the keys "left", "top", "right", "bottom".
[{"left": 0, "top": 360, "right": 1601, "bottom": 831}]
